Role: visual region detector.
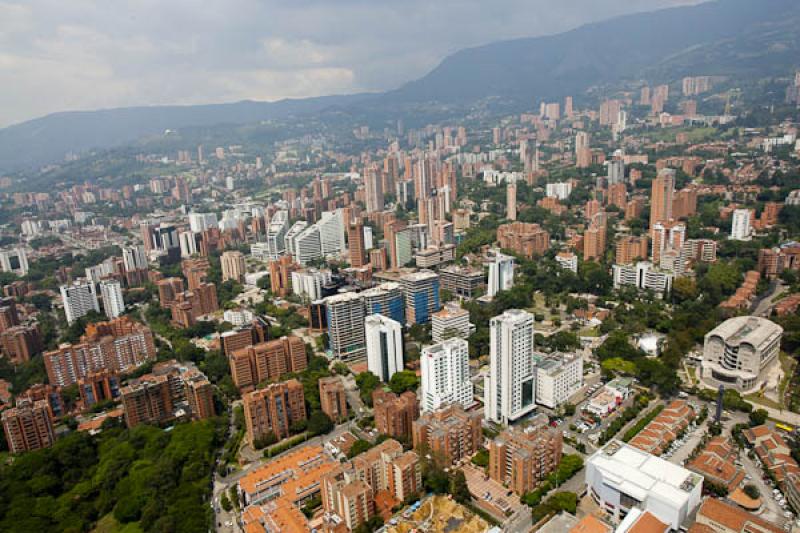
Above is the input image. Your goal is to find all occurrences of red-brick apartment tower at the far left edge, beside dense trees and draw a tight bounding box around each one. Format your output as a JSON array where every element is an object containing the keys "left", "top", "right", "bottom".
[{"left": 2, "top": 399, "right": 56, "bottom": 454}]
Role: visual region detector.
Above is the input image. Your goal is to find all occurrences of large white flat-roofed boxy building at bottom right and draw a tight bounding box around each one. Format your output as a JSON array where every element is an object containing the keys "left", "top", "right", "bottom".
[{"left": 586, "top": 440, "right": 703, "bottom": 531}]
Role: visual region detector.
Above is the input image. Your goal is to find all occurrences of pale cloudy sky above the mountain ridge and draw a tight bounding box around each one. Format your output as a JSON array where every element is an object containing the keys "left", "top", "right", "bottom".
[{"left": 0, "top": 0, "right": 697, "bottom": 127}]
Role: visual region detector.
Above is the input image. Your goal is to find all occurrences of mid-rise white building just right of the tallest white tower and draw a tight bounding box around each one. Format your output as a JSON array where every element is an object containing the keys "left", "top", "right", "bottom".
[{"left": 536, "top": 353, "right": 583, "bottom": 409}]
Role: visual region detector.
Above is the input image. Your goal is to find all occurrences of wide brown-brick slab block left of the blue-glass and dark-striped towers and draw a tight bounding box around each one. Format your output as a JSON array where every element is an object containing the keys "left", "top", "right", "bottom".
[{"left": 229, "top": 337, "right": 308, "bottom": 391}]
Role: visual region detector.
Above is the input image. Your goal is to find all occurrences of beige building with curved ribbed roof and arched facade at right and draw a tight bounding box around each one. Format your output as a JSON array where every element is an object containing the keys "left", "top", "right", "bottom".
[{"left": 701, "top": 316, "right": 783, "bottom": 392}]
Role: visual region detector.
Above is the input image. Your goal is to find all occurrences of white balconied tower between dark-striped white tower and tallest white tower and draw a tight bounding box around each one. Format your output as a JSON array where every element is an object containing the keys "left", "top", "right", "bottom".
[{"left": 420, "top": 338, "right": 473, "bottom": 412}]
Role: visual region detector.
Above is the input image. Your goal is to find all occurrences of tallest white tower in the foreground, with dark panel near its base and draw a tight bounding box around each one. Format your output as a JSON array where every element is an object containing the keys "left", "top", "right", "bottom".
[{"left": 484, "top": 309, "right": 536, "bottom": 424}]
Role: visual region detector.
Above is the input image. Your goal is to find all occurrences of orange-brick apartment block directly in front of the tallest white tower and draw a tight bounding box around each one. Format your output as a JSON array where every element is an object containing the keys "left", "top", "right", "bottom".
[{"left": 489, "top": 415, "right": 563, "bottom": 496}]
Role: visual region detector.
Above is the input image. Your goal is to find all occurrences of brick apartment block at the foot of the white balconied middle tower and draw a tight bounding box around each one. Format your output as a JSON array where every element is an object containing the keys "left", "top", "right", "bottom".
[{"left": 412, "top": 404, "right": 483, "bottom": 465}]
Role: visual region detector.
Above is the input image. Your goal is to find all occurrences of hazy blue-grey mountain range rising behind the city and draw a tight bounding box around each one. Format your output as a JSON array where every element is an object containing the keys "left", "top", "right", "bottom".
[{"left": 0, "top": 0, "right": 800, "bottom": 172}]
